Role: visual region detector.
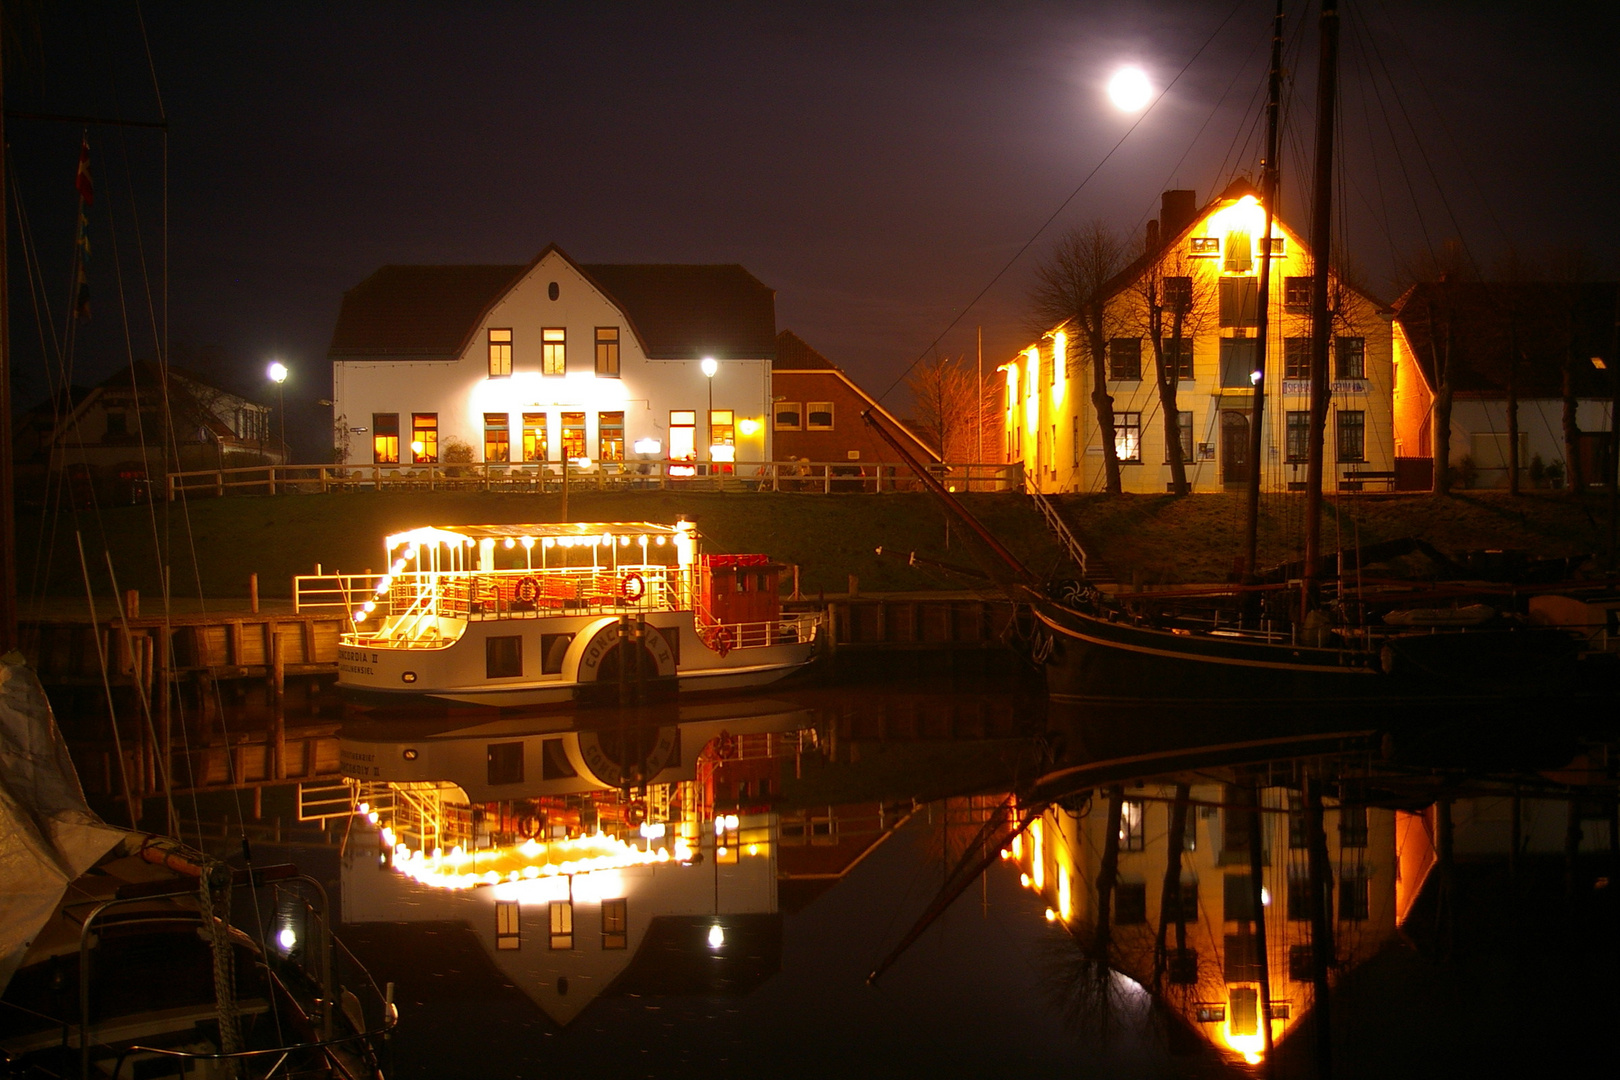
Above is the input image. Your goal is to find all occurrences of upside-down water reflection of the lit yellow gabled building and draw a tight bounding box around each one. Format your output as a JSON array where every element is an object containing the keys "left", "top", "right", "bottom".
[{"left": 1006, "top": 777, "right": 1434, "bottom": 1061}]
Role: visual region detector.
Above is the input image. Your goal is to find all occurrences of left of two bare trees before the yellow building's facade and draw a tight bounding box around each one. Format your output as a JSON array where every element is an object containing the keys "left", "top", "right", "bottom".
[{"left": 1030, "top": 220, "right": 1126, "bottom": 494}]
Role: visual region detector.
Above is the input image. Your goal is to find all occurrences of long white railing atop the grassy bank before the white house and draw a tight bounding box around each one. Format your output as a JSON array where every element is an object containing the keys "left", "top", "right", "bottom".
[{"left": 167, "top": 461, "right": 1024, "bottom": 500}]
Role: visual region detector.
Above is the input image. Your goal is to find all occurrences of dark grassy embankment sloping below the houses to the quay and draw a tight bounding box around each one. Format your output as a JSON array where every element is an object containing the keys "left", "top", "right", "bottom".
[{"left": 18, "top": 492, "right": 1607, "bottom": 599}]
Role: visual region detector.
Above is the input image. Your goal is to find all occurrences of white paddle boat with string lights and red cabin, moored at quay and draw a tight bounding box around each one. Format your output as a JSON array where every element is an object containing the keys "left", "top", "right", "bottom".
[{"left": 324, "top": 520, "right": 821, "bottom": 708}]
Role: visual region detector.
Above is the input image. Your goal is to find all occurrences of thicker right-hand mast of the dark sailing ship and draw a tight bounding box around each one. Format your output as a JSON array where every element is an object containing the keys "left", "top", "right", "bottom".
[{"left": 1304, "top": 0, "right": 1338, "bottom": 607}]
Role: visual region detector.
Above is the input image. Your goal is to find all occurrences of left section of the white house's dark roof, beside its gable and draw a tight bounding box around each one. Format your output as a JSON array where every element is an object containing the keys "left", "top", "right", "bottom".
[{"left": 326, "top": 266, "right": 528, "bottom": 359}]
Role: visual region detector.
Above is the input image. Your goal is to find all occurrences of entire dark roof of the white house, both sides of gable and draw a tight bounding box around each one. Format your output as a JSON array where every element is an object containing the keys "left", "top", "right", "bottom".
[{"left": 327, "top": 255, "right": 776, "bottom": 359}]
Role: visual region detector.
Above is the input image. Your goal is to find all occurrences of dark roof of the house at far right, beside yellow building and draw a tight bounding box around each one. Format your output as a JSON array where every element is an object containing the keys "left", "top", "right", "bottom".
[{"left": 1395, "top": 282, "right": 1620, "bottom": 398}]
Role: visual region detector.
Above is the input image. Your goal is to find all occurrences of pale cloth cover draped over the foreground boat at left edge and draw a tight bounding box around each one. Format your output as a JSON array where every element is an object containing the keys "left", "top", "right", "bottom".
[{"left": 0, "top": 654, "right": 128, "bottom": 991}]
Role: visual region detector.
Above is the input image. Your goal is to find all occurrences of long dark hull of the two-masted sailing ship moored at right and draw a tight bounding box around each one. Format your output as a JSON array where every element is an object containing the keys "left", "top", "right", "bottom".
[{"left": 1034, "top": 601, "right": 1580, "bottom": 704}]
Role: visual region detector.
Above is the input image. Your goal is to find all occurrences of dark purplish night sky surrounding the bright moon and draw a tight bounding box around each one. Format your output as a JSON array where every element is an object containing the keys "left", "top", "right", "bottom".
[{"left": 6, "top": 0, "right": 1620, "bottom": 455}]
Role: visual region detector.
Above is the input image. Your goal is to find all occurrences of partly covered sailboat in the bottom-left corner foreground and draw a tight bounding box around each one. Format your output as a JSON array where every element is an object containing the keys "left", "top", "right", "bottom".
[{"left": 0, "top": 664, "right": 395, "bottom": 1078}]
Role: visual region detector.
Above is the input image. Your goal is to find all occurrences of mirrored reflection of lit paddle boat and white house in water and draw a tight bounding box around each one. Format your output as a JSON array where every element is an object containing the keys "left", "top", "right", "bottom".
[{"left": 342, "top": 699, "right": 813, "bottom": 1023}]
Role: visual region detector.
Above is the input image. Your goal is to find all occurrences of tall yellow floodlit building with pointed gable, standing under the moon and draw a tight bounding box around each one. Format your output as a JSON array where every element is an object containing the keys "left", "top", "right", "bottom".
[{"left": 1003, "top": 181, "right": 1395, "bottom": 492}]
